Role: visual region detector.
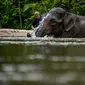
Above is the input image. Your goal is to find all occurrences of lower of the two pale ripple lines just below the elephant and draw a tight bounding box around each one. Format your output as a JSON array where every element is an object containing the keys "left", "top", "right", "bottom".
[{"left": 0, "top": 41, "right": 85, "bottom": 46}]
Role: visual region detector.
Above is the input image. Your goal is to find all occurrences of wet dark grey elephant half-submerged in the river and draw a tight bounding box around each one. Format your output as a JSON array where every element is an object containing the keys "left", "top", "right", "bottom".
[{"left": 35, "top": 8, "right": 85, "bottom": 38}]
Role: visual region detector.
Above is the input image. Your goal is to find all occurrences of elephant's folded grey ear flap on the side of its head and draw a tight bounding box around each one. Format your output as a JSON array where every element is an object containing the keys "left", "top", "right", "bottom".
[{"left": 64, "top": 13, "right": 76, "bottom": 31}]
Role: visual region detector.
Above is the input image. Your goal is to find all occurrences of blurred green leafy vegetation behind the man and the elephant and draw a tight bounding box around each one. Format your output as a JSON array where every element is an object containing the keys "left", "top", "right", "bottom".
[{"left": 0, "top": 0, "right": 85, "bottom": 30}]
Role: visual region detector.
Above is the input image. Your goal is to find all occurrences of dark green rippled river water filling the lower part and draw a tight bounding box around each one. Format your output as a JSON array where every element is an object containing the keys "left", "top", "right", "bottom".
[{"left": 0, "top": 37, "right": 85, "bottom": 85}]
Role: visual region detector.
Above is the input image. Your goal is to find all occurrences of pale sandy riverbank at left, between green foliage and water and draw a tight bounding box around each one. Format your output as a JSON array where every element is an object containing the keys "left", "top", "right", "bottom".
[{"left": 0, "top": 28, "right": 33, "bottom": 36}]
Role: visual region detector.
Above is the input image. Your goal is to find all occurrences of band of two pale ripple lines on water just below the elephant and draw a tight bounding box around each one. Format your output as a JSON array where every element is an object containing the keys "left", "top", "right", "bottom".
[{"left": 0, "top": 37, "right": 85, "bottom": 46}]
